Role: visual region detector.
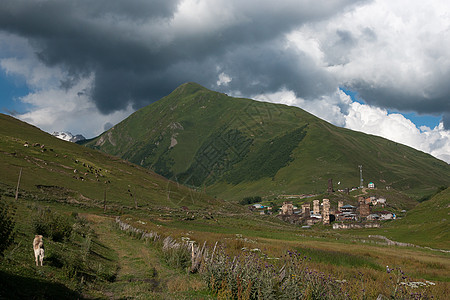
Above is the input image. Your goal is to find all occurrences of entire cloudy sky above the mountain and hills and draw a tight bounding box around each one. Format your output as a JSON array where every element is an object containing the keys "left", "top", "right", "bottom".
[{"left": 0, "top": 0, "right": 450, "bottom": 163}]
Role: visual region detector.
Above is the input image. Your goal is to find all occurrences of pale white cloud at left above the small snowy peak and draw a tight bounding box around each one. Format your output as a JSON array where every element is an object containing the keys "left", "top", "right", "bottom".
[{"left": 0, "top": 35, "right": 134, "bottom": 138}]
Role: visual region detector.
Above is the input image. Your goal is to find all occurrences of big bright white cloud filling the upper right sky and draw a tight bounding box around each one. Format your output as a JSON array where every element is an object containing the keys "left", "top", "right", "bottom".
[{"left": 288, "top": 0, "right": 450, "bottom": 113}]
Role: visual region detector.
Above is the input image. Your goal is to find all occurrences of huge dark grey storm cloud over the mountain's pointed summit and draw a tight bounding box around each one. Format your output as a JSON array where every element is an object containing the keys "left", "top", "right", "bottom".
[{"left": 0, "top": 0, "right": 362, "bottom": 113}]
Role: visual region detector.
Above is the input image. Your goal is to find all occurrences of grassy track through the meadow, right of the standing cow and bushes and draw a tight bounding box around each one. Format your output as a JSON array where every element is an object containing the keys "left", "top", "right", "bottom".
[{"left": 86, "top": 214, "right": 203, "bottom": 299}]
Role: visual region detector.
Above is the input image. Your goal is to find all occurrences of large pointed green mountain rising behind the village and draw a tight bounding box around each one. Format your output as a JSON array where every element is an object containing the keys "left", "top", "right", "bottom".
[{"left": 82, "top": 83, "right": 450, "bottom": 199}]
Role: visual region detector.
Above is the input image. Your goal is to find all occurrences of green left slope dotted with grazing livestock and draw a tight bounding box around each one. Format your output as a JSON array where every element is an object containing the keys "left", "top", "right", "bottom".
[{"left": 0, "top": 114, "right": 221, "bottom": 210}]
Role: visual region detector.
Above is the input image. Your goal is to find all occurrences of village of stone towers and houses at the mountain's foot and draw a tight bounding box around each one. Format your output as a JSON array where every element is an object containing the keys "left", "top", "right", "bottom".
[{"left": 249, "top": 182, "right": 397, "bottom": 229}]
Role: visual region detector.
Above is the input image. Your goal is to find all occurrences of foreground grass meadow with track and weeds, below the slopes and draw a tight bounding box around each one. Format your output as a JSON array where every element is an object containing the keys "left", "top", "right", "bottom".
[{"left": 0, "top": 190, "right": 450, "bottom": 299}]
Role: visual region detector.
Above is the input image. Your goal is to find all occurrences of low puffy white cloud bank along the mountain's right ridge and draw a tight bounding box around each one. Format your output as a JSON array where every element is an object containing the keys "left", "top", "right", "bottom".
[{"left": 254, "top": 89, "right": 450, "bottom": 163}]
